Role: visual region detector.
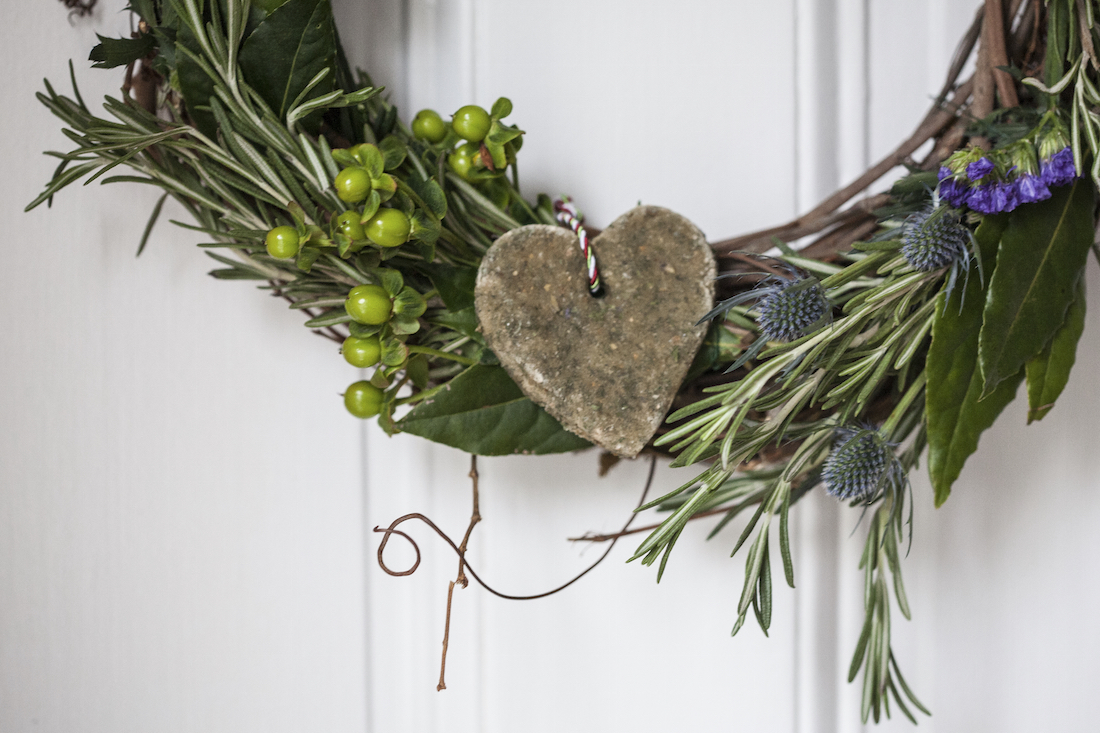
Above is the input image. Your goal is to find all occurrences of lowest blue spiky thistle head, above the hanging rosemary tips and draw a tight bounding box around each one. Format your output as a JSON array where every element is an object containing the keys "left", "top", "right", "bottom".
[{"left": 822, "top": 428, "right": 904, "bottom": 502}]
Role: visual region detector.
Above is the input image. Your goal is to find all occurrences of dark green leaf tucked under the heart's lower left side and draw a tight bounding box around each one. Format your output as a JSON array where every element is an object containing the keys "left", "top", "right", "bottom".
[{"left": 398, "top": 365, "right": 589, "bottom": 456}]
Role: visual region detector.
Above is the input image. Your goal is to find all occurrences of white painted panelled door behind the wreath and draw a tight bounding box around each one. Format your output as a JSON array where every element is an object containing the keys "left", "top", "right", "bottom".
[{"left": 0, "top": 0, "right": 1100, "bottom": 733}]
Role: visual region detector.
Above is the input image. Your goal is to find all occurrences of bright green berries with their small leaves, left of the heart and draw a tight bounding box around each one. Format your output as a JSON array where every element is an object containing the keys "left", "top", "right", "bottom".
[{"left": 256, "top": 98, "right": 528, "bottom": 422}]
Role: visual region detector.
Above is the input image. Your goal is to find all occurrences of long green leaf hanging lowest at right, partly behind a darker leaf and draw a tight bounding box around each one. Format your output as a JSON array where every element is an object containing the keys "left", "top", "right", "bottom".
[{"left": 925, "top": 216, "right": 1022, "bottom": 506}]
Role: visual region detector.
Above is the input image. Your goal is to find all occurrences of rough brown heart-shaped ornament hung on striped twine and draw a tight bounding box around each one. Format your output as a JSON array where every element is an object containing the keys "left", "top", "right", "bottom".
[{"left": 474, "top": 206, "right": 716, "bottom": 458}]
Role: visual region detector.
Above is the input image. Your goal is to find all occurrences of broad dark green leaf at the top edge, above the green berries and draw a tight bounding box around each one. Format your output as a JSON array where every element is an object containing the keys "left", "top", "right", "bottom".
[{"left": 240, "top": 0, "right": 337, "bottom": 119}]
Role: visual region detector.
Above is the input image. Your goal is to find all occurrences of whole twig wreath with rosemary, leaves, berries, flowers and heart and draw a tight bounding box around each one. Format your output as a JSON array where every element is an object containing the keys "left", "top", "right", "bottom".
[{"left": 28, "top": 0, "right": 1100, "bottom": 722}]
